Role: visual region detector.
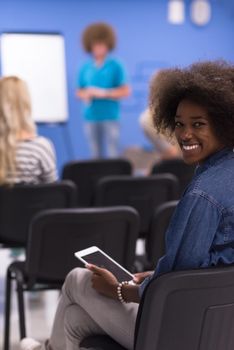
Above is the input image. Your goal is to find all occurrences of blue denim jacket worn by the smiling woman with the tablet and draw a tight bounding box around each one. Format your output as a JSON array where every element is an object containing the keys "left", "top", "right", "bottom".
[{"left": 140, "top": 148, "right": 234, "bottom": 295}]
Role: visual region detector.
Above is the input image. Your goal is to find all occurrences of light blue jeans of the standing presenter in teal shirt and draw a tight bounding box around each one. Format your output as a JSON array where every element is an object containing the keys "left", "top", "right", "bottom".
[{"left": 85, "top": 121, "right": 120, "bottom": 158}]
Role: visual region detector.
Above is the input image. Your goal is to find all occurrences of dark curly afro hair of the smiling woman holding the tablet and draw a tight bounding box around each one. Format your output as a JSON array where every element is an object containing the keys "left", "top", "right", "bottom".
[{"left": 150, "top": 61, "right": 234, "bottom": 147}]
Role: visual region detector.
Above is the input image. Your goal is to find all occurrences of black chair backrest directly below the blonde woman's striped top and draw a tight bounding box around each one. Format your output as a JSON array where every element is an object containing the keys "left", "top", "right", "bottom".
[{"left": 0, "top": 181, "right": 76, "bottom": 247}]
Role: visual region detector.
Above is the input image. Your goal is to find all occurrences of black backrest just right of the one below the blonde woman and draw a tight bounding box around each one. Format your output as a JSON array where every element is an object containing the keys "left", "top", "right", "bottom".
[{"left": 95, "top": 174, "right": 178, "bottom": 236}]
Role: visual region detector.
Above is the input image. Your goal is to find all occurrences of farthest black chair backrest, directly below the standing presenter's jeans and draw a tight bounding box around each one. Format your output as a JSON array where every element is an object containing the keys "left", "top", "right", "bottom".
[{"left": 62, "top": 159, "right": 132, "bottom": 207}]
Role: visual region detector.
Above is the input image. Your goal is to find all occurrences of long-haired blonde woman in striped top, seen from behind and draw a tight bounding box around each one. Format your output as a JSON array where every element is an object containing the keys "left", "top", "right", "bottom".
[{"left": 0, "top": 77, "right": 57, "bottom": 185}]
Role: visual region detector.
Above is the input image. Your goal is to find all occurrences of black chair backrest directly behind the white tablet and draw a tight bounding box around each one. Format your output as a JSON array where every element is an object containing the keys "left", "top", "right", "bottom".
[{"left": 26, "top": 207, "right": 139, "bottom": 282}]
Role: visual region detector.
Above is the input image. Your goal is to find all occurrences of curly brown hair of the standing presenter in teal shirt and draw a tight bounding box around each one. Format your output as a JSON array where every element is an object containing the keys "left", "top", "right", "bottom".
[{"left": 82, "top": 22, "right": 116, "bottom": 52}]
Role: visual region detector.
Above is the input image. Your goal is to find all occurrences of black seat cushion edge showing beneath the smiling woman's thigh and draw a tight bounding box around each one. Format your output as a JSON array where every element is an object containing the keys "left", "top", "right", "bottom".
[{"left": 80, "top": 335, "right": 126, "bottom": 350}]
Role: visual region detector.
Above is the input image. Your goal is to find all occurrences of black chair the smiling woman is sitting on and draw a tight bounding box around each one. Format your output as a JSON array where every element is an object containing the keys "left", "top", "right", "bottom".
[{"left": 81, "top": 266, "right": 234, "bottom": 350}]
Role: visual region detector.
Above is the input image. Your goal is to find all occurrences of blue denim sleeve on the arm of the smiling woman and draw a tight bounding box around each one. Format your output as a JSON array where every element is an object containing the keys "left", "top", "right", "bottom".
[{"left": 140, "top": 191, "right": 222, "bottom": 295}]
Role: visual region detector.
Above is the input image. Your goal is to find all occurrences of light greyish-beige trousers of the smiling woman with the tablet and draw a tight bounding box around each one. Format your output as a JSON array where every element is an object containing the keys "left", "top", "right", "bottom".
[{"left": 46, "top": 268, "right": 138, "bottom": 350}]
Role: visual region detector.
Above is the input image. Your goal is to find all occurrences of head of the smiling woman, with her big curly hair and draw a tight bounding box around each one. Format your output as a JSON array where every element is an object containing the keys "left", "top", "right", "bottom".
[{"left": 150, "top": 61, "right": 234, "bottom": 158}]
